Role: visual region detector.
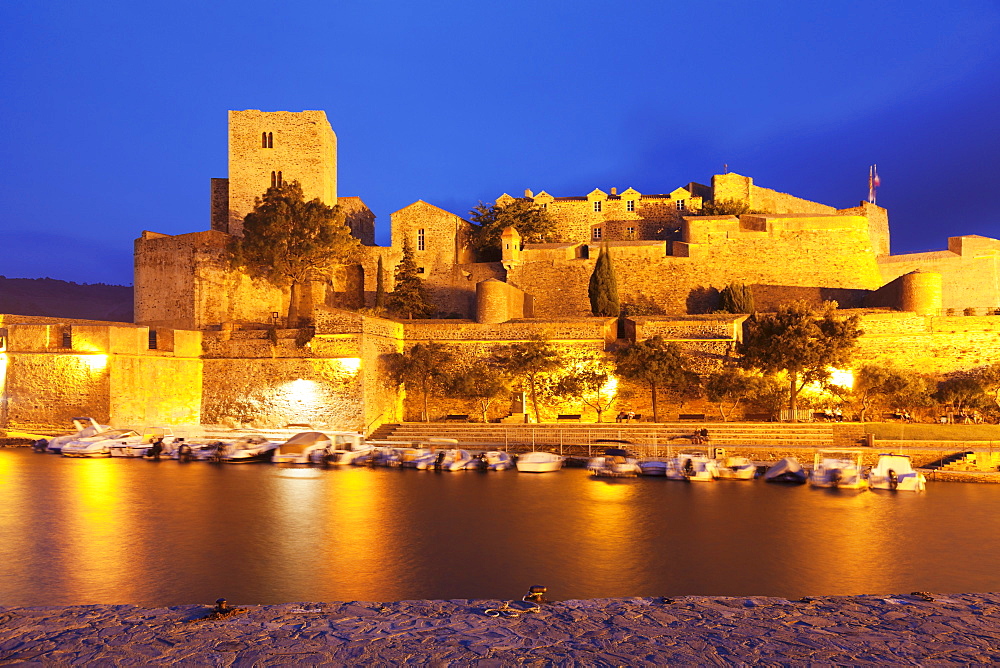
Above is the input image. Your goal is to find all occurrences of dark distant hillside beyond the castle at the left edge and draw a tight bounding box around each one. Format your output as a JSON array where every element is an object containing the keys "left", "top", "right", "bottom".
[{"left": 0, "top": 276, "right": 132, "bottom": 322}]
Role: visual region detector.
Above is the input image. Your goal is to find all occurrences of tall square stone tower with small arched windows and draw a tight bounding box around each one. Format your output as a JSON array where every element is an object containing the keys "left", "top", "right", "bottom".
[{"left": 212, "top": 109, "right": 337, "bottom": 235}]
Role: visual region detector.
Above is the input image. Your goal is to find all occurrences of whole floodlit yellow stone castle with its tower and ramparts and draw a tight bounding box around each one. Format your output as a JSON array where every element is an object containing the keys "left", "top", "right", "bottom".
[{"left": 0, "top": 110, "right": 1000, "bottom": 432}]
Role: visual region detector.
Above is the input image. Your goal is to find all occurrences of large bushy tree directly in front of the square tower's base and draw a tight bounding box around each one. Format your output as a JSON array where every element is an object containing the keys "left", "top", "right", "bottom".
[{"left": 229, "top": 181, "right": 360, "bottom": 327}]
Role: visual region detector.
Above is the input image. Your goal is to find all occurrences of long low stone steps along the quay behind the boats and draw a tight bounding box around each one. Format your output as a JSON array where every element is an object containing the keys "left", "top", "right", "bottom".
[{"left": 369, "top": 422, "right": 836, "bottom": 449}]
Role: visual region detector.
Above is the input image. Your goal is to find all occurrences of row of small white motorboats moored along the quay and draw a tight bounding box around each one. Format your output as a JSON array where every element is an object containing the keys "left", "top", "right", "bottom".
[{"left": 39, "top": 418, "right": 925, "bottom": 491}]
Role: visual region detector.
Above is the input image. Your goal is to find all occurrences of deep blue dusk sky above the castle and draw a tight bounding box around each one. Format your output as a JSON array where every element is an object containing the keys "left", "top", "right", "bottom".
[{"left": 0, "top": 0, "right": 1000, "bottom": 284}]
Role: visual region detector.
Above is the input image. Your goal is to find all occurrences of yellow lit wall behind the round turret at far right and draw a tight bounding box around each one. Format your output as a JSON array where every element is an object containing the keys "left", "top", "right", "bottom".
[{"left": 878, "top": 236, "right": 1000, "bottom": 312}]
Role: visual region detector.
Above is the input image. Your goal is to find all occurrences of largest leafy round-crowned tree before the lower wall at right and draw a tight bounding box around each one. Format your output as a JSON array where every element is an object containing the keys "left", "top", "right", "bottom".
[{"left": 737, "top": 301, "right": 862, "bottom": 421}]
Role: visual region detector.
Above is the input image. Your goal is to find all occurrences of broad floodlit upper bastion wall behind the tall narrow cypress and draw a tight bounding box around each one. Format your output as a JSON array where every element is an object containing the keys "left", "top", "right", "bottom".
[{"left": 507, "top": 216, "right": 882, "bottom": 318}]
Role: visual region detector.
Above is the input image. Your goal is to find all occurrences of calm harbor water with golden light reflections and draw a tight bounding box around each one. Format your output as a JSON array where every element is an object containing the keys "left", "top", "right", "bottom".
[{"left": 0, "top": 449, "right": 1000, "bottom": 606}]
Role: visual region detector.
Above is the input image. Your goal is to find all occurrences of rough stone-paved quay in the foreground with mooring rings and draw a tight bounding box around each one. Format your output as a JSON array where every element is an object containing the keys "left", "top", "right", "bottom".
[{"left": 0, "top": 592, "right": 1000, "bottom": 666}]
